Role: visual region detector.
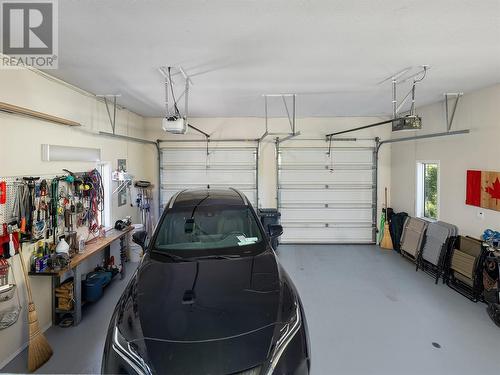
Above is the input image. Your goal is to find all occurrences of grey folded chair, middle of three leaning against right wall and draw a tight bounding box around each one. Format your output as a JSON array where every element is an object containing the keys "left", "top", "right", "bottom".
[{"left": 417, "top": 221, "right": 458, "bottom": 284}]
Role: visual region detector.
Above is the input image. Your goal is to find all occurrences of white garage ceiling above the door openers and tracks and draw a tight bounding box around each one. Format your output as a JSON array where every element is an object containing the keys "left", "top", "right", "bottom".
[{"left": 49, "top": 0, "right": 500, "bottom": 117}]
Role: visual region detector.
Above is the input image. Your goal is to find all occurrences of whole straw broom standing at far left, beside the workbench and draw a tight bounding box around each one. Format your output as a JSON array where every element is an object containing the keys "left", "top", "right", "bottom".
[{"left": 19, "top": 244, "right": 52, "bottom": 372}]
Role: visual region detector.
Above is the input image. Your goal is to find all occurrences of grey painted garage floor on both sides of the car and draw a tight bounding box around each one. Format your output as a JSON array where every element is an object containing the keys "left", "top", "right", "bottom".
[{"left": 2, "top": 245, "right": 500, "bottom": 375}]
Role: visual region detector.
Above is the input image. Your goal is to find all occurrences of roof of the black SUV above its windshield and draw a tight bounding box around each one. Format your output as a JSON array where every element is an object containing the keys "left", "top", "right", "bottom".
[{"left": 169, "top": 188, "right": 249, "bottom": 208}]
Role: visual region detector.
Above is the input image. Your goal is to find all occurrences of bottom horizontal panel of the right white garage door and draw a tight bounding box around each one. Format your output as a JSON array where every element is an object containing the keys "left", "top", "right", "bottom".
[{"left": 281, "top": 225, "right": 373, "bottom": 243}]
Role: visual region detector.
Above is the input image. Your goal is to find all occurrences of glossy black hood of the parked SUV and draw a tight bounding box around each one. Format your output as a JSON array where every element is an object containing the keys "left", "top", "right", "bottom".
[{"left": 118, "top": 251, "right": 281, "bottom": 373}]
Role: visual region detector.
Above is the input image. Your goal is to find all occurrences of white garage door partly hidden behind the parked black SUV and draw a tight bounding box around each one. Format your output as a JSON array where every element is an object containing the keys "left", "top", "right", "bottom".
[{"left": 161, "top": 147, "right": 257, "bottom": 208}]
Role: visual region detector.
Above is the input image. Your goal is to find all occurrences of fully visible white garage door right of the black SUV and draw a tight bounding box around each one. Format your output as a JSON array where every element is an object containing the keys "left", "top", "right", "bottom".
[{"left": 278, "top": 147, "right": 376, "bottom": 243}]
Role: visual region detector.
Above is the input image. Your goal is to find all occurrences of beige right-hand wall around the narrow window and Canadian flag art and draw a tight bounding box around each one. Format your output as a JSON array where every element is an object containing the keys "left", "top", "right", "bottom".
[{"left": 390, "top": 85, "right": 500, "bottom": 237}]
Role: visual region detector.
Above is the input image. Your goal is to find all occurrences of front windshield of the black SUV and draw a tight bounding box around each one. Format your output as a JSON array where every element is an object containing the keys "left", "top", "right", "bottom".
[{"left": 154, "top": 205, "right": 262, "bottom": 256}]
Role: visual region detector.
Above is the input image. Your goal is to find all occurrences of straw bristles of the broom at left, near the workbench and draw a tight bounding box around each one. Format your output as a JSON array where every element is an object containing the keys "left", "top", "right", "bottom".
[{"left": 28, "top": 302, "right": 53, "bottom": 372}]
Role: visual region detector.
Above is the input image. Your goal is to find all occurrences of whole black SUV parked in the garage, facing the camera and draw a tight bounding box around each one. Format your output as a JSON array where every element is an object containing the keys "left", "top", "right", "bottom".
[{"left": 102, "top": 189, "right": 310, "bottom": 375}]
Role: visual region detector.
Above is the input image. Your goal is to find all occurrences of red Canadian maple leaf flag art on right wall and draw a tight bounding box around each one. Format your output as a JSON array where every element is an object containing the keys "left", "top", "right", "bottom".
[{"left": 465, "top": 171, "right": 500, "bottom": 211}]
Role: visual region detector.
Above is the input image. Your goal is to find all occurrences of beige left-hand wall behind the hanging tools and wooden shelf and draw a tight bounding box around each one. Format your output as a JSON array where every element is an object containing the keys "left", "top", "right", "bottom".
[{"left": 0, "top": 70, "right": 151, "bottom": 368}]
